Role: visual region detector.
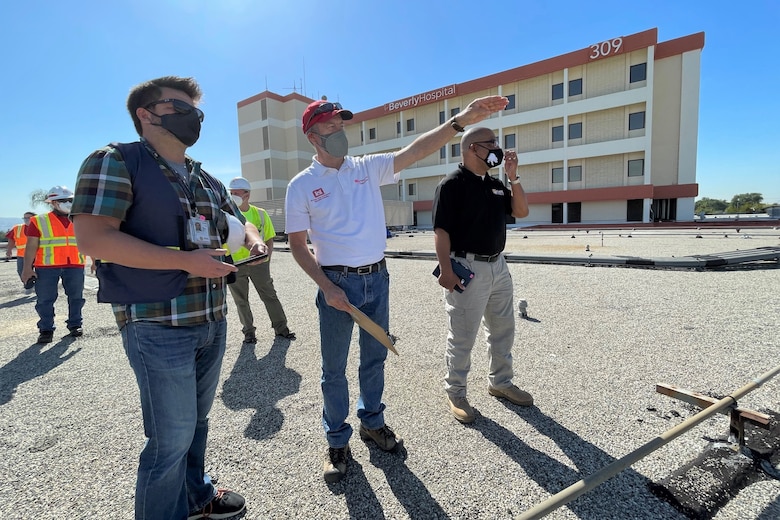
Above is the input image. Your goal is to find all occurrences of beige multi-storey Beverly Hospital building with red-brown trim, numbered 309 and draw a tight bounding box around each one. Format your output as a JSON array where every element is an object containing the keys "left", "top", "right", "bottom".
[{"left": 238, "top": 29, "right": 704, "bottom": 230}]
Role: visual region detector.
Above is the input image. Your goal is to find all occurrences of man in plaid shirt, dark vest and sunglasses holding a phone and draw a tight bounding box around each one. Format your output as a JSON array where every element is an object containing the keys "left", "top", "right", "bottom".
[{"left": 71, "top": 76, "right": 266, "bottom": 520}]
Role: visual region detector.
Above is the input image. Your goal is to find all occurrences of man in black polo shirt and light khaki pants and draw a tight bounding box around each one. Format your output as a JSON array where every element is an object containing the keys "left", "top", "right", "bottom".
[{"left": 433, "top": 128, "right": 533, "bottom": 423}]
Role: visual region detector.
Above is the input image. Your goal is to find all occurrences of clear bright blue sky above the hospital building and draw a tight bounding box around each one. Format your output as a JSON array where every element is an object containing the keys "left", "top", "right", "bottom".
[{"left": 0, "top": 0, "right": 780, "bottom": 217}]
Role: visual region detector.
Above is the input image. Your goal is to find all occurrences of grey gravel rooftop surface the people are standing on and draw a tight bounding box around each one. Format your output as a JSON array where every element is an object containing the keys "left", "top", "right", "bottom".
[{"left": 0, "top": 228, "right": 780, "bottom": 520}]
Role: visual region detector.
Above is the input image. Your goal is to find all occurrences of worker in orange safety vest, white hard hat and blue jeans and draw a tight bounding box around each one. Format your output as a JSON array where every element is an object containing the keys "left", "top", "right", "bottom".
[{"left": 22, "top": 186, "right": 84, "bottom": 343}]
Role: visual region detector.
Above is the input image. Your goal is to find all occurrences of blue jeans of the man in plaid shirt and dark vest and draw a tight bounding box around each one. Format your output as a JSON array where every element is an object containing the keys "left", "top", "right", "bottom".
[{"left": 121, "top": 320, "right": 227, "bottom": 520}]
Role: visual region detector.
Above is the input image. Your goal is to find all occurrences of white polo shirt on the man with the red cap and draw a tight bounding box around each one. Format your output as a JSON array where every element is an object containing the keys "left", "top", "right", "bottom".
[{"left": 285, "top": 153, "right": 399, "bottom": 267}]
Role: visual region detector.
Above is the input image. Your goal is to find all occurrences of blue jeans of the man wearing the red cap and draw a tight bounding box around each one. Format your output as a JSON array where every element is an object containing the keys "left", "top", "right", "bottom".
[{"left": 317, "top": 269, "right": 390, "bottom": 448}]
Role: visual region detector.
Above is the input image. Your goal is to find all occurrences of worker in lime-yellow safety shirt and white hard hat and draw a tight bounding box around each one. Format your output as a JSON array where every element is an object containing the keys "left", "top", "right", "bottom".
[{"left": 228, "top": 177, "right": 295, "bottom": 343}]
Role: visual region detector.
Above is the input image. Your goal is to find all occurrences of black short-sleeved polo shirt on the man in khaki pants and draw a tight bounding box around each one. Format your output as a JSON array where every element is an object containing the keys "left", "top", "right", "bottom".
[{"left": 433, "top": 164, "right": 512, "bottom": 255}]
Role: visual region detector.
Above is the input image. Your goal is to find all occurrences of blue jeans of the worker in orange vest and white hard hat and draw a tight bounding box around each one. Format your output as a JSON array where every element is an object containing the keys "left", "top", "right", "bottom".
[{"left": 35, "top": 266, "right": 84, "bottom": 330}]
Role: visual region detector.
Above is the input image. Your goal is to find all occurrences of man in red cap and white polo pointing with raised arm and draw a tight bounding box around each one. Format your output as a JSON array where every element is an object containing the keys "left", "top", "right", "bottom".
[{"left": 285, "top": 96, "right": 509, "bottom": 482}]
